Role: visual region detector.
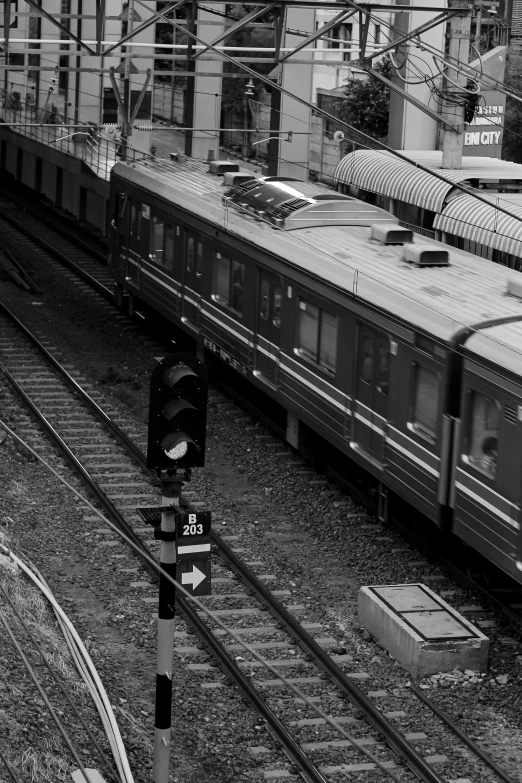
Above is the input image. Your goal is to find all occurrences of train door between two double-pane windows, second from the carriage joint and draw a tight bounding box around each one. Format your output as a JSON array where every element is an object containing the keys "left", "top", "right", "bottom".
[{"left": 256, "top": 269, "right": 281, "bottom": 386}]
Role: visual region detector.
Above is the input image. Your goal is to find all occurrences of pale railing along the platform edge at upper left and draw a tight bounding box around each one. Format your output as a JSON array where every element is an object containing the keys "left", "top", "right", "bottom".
[{"left": 0, "top": 90, "right": 149, "bottom": 180}]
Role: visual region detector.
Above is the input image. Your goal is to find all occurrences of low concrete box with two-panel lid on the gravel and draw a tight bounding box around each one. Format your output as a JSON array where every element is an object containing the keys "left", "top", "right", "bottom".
[{"left": 359, "top": 584, "right": 489, "bottom": 679}]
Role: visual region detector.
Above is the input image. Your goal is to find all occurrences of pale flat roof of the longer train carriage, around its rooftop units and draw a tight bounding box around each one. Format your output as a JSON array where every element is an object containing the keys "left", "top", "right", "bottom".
[{"left": 112, "top": 158, "right": 522, "bottom": 350}]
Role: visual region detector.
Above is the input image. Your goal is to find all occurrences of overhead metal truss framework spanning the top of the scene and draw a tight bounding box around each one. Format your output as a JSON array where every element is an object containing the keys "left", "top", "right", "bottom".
[{"left": 0, "top": 0, "right": 504, "bottom": 173}]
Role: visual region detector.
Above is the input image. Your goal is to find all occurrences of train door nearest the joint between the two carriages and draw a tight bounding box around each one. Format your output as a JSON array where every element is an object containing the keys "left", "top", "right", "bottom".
[{"left": 353, "top": 326, "right": 390, "bottom": 463}]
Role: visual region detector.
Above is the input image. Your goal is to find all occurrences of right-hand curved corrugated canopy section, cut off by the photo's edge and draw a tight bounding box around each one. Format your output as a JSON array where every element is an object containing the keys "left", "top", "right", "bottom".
[{"left": 433, "top": 191, "right": 522, "bottom": 256}]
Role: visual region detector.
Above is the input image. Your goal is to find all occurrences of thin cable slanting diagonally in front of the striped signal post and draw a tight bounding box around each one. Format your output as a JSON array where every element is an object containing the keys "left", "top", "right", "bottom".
[{"left": 0, "top": 419, "right": 414, "bottom": 783}]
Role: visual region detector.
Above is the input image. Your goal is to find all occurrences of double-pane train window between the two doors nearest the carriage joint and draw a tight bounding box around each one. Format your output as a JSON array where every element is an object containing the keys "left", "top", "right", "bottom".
[{"left": 297, "top": 299, "right": 338, "bottom": 374}]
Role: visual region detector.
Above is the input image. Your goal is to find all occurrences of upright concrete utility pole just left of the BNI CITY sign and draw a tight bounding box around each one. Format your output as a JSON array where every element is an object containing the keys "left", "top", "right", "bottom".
[{"left": 441, "top": 0, "right": 471, "bottom": 169}]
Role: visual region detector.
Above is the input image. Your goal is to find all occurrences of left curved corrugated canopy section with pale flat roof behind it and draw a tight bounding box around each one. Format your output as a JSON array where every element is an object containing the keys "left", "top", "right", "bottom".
[{"left": 334, "top": 150, "right": 522, "bottom": 212}]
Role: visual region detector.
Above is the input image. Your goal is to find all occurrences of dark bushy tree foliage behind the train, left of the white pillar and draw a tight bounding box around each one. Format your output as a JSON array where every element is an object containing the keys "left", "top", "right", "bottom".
[{"left": 337, "top": 57, "right": 392, "bottom": 146}]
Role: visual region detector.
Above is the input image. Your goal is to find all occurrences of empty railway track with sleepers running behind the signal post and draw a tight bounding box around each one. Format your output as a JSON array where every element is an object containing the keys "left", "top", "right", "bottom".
[{"left": 0, "top": 307, "right": 507, "bottom": 783}]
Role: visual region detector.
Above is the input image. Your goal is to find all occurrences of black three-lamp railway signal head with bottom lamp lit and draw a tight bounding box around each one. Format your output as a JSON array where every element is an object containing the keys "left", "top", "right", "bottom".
[{"left": 147, "top": 353, "right": 208, "bottom": 472}]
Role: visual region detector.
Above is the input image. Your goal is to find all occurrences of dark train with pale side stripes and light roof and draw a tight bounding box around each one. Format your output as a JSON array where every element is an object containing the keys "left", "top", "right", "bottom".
[{"left": 109, "top": 156, "right": 522, "bottom": 583}]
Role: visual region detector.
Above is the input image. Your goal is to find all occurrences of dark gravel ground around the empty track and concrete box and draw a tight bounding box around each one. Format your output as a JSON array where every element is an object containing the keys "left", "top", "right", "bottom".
[{"left": 0, "top": 216, "right": 522, "bottom": 783}]
